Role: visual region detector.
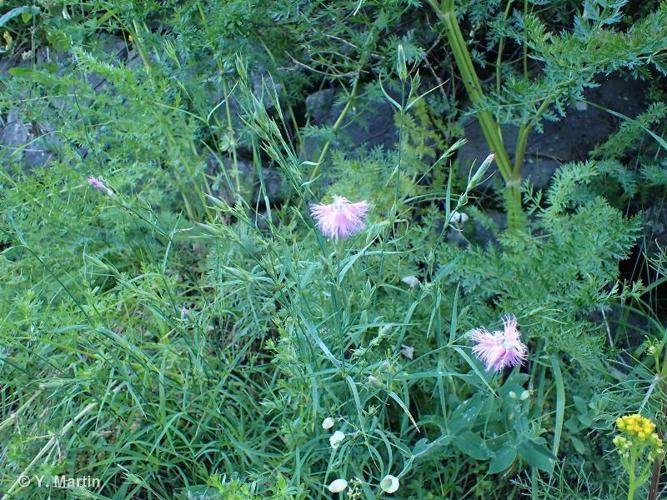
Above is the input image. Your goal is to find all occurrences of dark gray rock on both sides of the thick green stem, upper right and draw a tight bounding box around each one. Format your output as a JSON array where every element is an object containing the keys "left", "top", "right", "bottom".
[{"left": 458, "top": 78, "right": 646, "bottom": 189}]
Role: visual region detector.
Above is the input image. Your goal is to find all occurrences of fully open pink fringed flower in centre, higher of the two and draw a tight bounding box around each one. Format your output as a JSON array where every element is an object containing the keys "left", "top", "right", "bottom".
[{"left": 310, "top": 196, "right": 368, "bottom": 240}]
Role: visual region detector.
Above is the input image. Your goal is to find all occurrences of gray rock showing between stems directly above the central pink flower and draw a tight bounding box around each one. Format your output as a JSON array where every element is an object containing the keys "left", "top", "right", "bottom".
[{"left": 302, "top": 89, "right": 398, "bottom": 160}]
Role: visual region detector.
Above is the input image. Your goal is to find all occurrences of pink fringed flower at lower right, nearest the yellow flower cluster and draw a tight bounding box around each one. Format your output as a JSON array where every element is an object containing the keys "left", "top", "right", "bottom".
[{"left": 471, "top": 315, "right": 527, "bottom": 371}]
